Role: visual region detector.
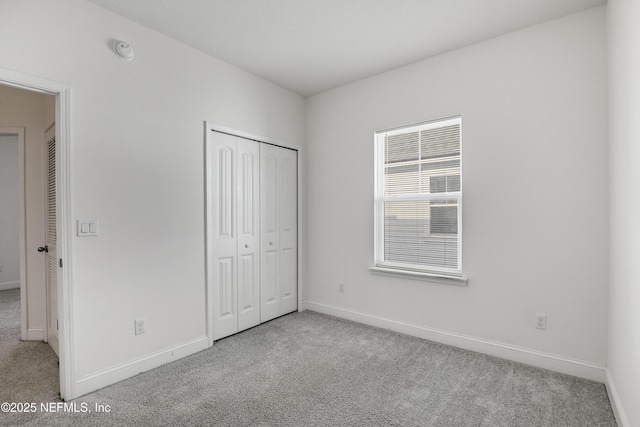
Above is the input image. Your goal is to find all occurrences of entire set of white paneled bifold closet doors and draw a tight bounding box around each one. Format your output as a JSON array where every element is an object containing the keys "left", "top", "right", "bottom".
[{"left": 206, "top": 124, "right": 298, "bottom": 345}]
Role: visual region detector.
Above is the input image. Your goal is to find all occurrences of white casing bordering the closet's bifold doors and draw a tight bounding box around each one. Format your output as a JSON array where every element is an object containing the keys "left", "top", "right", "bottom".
[{"left": 204, "top": 121, "right": 304, "bottom": 347}]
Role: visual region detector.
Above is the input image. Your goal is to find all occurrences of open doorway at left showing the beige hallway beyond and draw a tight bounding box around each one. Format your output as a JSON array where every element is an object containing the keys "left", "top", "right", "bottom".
[{"left": 0, "top": 85, "right": 60, "bottom": 401}]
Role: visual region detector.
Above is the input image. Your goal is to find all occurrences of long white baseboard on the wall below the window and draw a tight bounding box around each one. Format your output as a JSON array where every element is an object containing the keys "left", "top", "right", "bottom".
[{"left": 304, "top": 301, "right": 606, "bottom": 383}]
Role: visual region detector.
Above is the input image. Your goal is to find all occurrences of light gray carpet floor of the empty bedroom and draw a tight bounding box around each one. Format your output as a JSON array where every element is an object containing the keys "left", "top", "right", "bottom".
[{"left": 0, "top": 290, "right": 616, "bottom": 427}]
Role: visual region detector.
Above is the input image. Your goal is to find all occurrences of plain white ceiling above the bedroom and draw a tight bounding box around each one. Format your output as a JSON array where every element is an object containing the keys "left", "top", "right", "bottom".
[{"left": 88, "top": 0, "right": 606, "bottom": 96}]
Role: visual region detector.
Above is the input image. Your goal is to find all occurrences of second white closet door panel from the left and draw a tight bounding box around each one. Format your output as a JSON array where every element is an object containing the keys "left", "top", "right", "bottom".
[{"left": 236, "top": 138, "right": 260, "bottom": 331}]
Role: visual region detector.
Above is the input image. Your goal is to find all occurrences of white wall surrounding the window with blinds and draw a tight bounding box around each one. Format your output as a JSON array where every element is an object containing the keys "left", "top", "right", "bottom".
[{"left": 307, "top": 7, "right": 608, "bottom": 374}]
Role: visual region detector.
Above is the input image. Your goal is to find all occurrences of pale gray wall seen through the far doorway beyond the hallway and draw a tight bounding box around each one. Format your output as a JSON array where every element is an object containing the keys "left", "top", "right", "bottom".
[{"left": 0, "top": 135, "right": 20, "bottom": 290}]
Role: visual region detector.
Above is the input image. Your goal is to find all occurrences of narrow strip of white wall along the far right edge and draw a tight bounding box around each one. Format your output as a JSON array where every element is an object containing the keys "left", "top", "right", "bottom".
[{"left": 607, "top": 0, "right": 640, "bottom": 426}]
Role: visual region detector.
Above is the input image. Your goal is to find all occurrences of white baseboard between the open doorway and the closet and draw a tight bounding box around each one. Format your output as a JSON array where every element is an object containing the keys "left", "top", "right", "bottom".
[{"left": 70, "top": 336, "right": 209, "bottom": 399}]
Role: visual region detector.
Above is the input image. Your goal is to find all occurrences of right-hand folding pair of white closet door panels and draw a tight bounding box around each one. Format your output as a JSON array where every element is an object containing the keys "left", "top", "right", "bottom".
[{"left": 260, "top": 144, "right": 298, "bottom": 322}]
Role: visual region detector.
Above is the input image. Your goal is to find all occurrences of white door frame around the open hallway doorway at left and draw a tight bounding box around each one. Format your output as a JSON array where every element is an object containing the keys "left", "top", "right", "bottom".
[{"left": 0, "top": 68, "right": 77, "bottom": 400}]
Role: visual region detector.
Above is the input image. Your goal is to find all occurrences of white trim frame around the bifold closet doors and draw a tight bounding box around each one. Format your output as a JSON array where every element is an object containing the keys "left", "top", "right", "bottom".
[{"left": 204, "top": 121, "right": 305, "bottom": 347}]
